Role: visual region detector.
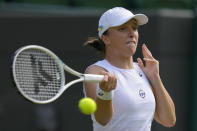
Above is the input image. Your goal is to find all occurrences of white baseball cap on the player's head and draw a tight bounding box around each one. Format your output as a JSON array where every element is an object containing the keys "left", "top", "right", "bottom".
[{"left": 98, "top": 7, "right": 148, "bottom": 38}]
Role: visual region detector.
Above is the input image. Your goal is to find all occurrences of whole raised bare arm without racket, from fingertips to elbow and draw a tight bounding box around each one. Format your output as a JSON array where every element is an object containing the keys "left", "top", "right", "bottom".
[{"left": 138, "top": 45, "right": 176, "bottom": 127}]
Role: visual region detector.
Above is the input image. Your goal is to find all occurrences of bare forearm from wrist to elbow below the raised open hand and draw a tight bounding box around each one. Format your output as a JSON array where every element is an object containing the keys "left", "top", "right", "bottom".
[{"left": 150, "top": 75, "right": 176, "bottom": 126}]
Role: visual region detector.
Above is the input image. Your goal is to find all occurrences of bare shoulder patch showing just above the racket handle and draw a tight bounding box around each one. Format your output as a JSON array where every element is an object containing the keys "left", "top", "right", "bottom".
[{"left": 85, "top": 65, "right": 106, "bottom": 74}]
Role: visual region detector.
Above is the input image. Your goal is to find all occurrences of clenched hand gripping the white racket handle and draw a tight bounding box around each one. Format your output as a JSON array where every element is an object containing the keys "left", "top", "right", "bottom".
[{"left": 100, "top": 71, "right": 117, "bottom": 91}]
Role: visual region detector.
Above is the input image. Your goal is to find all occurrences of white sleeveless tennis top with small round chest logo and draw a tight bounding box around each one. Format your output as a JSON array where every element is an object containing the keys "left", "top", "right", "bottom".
[{"left": 84, "top": 60, "right": 155, "bottom": 131}]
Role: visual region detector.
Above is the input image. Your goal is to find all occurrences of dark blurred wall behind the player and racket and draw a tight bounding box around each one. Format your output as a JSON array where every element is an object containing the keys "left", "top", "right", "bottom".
[{"left": 0, "top": 2, "right": 194, "bottom": 131}]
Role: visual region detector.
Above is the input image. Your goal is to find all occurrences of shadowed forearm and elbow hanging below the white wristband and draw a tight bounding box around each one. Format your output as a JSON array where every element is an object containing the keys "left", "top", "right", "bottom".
[{"left": 94, "top": 98, "right": 113, "bottom": 126}]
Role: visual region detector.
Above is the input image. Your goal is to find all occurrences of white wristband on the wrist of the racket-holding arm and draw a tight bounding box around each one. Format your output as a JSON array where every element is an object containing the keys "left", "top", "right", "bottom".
[{"left": 96, "top": 86, "right": 114, "bottom": 100}]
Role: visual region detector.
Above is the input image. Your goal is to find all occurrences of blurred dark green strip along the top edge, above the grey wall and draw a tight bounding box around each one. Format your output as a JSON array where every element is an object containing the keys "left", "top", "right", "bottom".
[{"left": 0, "top": 0, "right": 194, "bottom": 9}]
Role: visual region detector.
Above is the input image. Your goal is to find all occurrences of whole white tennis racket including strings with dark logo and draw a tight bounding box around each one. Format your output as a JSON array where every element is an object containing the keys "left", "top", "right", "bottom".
[{"left": 11, "top": 45, "right": 104, "bottom": 104}]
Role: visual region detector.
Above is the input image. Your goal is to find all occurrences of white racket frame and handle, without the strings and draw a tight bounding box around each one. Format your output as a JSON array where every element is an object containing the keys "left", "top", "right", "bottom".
[{"left": 12, "top": 45, "right": 104, "bottom": 104}]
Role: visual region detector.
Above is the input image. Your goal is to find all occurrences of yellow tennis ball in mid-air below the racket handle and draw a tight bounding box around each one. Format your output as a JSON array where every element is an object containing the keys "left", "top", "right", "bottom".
[{"left": 78, "top": 97, "right": 97, "bottom": 115}]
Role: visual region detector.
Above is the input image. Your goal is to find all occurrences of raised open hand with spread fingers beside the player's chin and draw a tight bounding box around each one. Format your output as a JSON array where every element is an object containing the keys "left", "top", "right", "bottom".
[{"left": 137, "top": 44, "right": 159, "bottom": 80}]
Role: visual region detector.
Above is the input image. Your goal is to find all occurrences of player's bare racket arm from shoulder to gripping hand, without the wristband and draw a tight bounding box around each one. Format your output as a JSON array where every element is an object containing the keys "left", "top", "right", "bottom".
[{"left": 84, "top": 66, "right": 117, "bottom": 126}]
